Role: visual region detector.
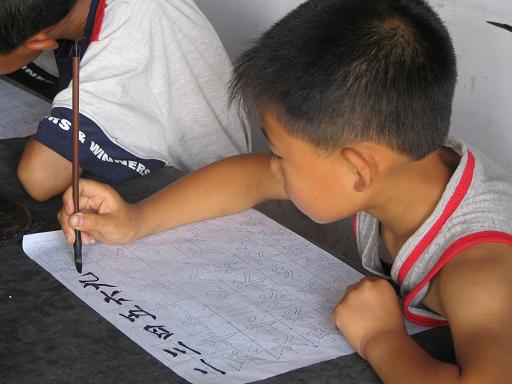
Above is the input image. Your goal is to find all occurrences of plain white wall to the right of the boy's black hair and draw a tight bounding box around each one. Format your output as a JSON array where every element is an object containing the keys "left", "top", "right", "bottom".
[{"left": 431, "top": 0, "right": 512, "bottom": 170}]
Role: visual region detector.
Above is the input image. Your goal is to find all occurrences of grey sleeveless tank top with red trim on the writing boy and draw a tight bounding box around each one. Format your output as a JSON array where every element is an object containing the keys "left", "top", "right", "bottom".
[{"left": 354, "top": 137, "right": 512, "bottom": 326}]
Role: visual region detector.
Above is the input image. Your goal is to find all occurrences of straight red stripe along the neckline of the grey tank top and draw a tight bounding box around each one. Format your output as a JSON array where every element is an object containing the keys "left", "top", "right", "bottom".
[{"left": 397, "top": 151, "right": 475, "bottom": 285}]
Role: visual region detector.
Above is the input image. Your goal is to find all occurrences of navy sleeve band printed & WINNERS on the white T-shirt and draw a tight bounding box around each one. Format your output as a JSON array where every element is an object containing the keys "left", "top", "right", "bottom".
[{"left": 34, "top": 108, "right": 165, "bottom": 183}]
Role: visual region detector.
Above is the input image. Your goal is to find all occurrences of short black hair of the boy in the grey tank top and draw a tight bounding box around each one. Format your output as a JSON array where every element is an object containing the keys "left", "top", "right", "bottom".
[{"left": 230, "top": 0, "right": 457, "bottom": 159}]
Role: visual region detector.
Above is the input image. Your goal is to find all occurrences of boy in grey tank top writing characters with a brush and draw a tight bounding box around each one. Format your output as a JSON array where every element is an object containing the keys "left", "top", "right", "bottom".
[{"left": 60, "top": 0, "right": 512, "bottom": 384}]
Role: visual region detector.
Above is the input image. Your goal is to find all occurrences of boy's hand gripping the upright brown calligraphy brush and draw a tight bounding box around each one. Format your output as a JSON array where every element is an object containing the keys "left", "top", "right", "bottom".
[{"left": 57, "top": 179, "right": 138, "bottom": 244}]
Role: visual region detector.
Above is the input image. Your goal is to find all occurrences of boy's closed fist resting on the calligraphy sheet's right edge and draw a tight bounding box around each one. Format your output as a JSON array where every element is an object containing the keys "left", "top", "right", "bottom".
[{"left": 333, "top": 277, "right": 407, "bottom": 359}]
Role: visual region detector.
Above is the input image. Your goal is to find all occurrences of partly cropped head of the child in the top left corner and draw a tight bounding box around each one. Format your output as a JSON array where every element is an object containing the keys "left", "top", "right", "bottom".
[{"left": 0, "top": 0, "right": 78, "bottom": 74}]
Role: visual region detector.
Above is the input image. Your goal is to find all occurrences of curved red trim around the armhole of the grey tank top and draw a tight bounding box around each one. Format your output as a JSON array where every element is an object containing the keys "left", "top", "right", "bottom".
[{"left": 404, "top": 231, "right": 512, "bottom": 327}]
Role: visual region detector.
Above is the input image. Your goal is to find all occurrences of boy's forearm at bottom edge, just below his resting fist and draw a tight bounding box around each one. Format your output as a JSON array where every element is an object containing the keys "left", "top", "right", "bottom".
[{"left": 364, "top": 332, "right": 462, "bottom": 384}]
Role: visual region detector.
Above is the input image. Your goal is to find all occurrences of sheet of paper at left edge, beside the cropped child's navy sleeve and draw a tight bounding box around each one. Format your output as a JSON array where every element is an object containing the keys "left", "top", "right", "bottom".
[{"left": 0, "top": 80, "right": 50, "bottom": 140}]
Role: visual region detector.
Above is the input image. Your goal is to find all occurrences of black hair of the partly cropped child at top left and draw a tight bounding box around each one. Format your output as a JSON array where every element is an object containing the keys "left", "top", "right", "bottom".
[{"left": 0, "top": 0, "right": 77, "bottom": 54}]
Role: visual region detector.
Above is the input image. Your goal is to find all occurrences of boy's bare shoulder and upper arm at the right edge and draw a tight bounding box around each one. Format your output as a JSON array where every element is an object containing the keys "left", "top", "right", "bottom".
[{"left": 430, "top": 243, "right": 512, "bottom": 384}]
